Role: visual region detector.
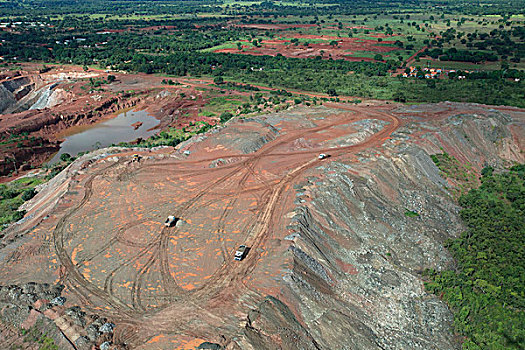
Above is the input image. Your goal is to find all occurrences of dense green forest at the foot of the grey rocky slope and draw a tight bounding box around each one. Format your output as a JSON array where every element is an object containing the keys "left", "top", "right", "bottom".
[{"left": 426, "top": 164, "right": 525, "bottom": 350}]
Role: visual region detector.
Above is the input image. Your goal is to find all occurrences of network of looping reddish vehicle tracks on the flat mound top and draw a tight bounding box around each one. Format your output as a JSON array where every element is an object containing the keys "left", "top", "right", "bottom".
[{"left": 53, "top": 103, "right": 400, "bottom": 342}]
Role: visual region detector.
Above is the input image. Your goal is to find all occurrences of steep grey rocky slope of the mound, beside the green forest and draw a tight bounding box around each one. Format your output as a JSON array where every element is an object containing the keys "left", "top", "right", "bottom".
[{"left": 235, "top": 105, "right": 523, "bottom": 349}]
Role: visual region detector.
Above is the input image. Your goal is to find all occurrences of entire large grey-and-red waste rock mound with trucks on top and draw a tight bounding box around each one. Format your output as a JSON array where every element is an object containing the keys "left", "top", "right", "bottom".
[{"left": 0, "top": 97, "right": 525, "bottom": 349}]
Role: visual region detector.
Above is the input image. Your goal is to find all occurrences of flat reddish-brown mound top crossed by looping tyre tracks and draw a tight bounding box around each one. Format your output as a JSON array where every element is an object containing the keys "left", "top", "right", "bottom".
[{"left": 6, "top": 104, "right": 400, "bottom": 348}]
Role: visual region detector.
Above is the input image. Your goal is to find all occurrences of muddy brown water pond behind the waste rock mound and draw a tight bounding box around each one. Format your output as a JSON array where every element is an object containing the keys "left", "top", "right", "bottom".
[{"left": 49, "top": 111, "right": 160, "bottom": 164}]
